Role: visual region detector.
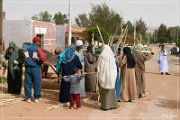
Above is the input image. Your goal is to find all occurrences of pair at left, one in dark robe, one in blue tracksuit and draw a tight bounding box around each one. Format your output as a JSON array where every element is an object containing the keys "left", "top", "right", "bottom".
[{"left": 5, "top": 37, "right": 45, "bottom": 102}]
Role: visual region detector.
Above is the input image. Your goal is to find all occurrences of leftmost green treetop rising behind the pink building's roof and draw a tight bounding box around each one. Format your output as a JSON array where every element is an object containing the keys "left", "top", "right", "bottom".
[{"left": 31, "top": 11, "right": 52, "bottom": 22}]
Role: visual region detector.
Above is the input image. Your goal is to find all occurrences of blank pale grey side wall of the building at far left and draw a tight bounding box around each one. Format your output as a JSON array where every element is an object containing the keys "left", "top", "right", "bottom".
[{"left": 3, "top": 20, "right": 32, "bottom": 49}]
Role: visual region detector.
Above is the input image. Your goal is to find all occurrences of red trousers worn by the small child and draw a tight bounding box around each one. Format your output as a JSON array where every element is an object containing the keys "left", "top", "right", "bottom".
[{"left": 70, "top": 94, "right": 81, "bottom": 108}]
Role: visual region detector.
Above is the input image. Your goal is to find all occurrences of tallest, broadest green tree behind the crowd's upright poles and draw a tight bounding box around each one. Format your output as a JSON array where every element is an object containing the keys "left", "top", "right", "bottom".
[{"left": 89, "top": 3, "right": 122, "bottom": 34}]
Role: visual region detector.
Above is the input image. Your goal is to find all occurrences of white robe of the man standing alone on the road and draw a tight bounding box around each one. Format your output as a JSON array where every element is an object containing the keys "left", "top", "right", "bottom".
[{"left": 158, "top": 50, "right": 168, "bottom": 72}]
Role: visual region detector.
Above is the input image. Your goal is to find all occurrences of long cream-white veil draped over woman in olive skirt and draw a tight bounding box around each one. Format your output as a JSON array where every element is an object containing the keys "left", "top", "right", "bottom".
[{"left": 97, "top": 45, "right": 117, "bottom": 89}]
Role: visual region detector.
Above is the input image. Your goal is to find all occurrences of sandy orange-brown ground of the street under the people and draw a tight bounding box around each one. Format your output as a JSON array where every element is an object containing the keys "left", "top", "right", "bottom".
[{"left": 0, "top": 46, "right": 180, "bottom": 120}]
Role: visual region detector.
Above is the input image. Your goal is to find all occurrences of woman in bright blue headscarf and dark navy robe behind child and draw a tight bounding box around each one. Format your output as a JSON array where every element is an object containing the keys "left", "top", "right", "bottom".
[{"left": 56, "top": 45, "right": 82, "bottom": 103}]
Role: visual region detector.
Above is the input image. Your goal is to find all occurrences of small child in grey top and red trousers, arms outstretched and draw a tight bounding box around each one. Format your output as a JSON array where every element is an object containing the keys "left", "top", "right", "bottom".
[{"left": 64, "top": 68, "right": 84, "bottom": 109}]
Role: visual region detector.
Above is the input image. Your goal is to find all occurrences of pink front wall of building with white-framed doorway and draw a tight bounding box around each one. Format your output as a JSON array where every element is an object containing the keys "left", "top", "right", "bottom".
[{"left": 32, "top": 21, "right": 56, "bottom": 52}]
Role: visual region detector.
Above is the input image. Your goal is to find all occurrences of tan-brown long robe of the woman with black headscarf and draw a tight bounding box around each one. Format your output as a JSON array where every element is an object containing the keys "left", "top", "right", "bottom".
[{"left": 120, "top": 56, "right": 137, "bottom": 101}]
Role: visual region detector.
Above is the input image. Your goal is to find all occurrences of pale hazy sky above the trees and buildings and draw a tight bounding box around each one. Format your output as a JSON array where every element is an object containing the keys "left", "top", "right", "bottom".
[{"left": 3, "top": 0, "right": 180, "bottom": 27}]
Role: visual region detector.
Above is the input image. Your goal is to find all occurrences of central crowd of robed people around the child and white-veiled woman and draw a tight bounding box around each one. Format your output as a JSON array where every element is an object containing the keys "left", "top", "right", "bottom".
[{"left": 56, "top": 40, "right": 155, "bottom": 110}]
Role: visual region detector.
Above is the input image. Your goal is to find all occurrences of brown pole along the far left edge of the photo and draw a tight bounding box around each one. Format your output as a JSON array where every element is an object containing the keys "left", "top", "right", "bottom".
[{"left": 0, "top": 0, "right": 3, "bottom": 54}]
